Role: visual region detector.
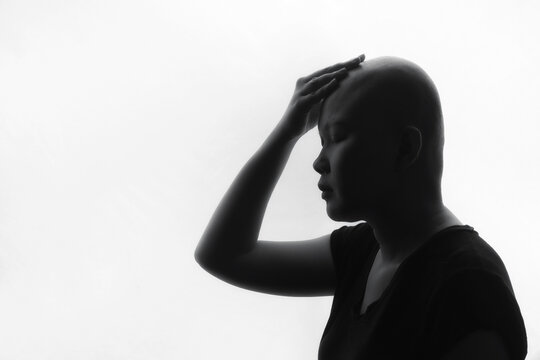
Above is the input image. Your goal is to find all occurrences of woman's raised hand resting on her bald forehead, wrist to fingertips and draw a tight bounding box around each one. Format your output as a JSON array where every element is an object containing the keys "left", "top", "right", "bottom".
[{"left": 277, "top": 54, "right": 365, "bottom": 139}]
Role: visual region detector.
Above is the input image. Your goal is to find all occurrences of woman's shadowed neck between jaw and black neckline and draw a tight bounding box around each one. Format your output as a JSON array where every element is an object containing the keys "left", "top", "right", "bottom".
[{"left": 366, "top": 201, "right": 461, "bottom": 263}]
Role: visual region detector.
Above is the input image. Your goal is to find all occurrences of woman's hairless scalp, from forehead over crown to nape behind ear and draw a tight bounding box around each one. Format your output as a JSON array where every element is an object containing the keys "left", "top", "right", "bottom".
[{"left": 321, "top": 57, "right": 444, "bottom": 186}]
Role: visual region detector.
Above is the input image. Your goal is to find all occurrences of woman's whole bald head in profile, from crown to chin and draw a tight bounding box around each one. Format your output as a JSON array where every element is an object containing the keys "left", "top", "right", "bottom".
[{"left": 313, "top": 57, "right": 444, "bottom": 221}]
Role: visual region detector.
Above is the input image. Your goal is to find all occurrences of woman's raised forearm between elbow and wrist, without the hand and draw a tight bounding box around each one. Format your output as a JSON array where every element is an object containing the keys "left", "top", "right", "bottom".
[{"left": 195, "top": 128, "right": 297, "bottom": 266}]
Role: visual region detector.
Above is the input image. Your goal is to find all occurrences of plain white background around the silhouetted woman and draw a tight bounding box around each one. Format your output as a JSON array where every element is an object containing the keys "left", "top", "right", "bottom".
[{"left": 0, "top": 0, "right": 540, "bottom": 360}]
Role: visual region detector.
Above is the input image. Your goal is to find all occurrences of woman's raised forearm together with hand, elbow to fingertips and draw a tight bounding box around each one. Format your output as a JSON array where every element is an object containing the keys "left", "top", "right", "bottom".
[{"left": 195, "top": 56, "right": 364, "bottom": 272}]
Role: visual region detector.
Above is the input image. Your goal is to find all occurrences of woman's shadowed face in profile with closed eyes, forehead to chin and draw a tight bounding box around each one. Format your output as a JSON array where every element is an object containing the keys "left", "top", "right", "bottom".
[{"left": 313, "top": 90, "right": 396, "bottom": 222}]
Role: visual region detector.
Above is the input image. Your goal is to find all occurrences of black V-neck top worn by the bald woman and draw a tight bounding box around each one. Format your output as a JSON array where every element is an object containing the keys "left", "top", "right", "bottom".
[{"left": 319, "top": 223, "right": 527, "bottom": 360}]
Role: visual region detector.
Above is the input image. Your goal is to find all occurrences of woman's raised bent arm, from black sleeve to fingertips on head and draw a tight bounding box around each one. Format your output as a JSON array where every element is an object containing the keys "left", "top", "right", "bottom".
[{"left": 195, "top": 58, "right": 362, "bottom": 296}]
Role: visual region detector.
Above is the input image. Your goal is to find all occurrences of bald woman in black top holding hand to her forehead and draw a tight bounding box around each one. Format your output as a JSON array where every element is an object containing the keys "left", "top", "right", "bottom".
[{"left": 195, "top": 55, "right": 527, "bottom": 360}]
